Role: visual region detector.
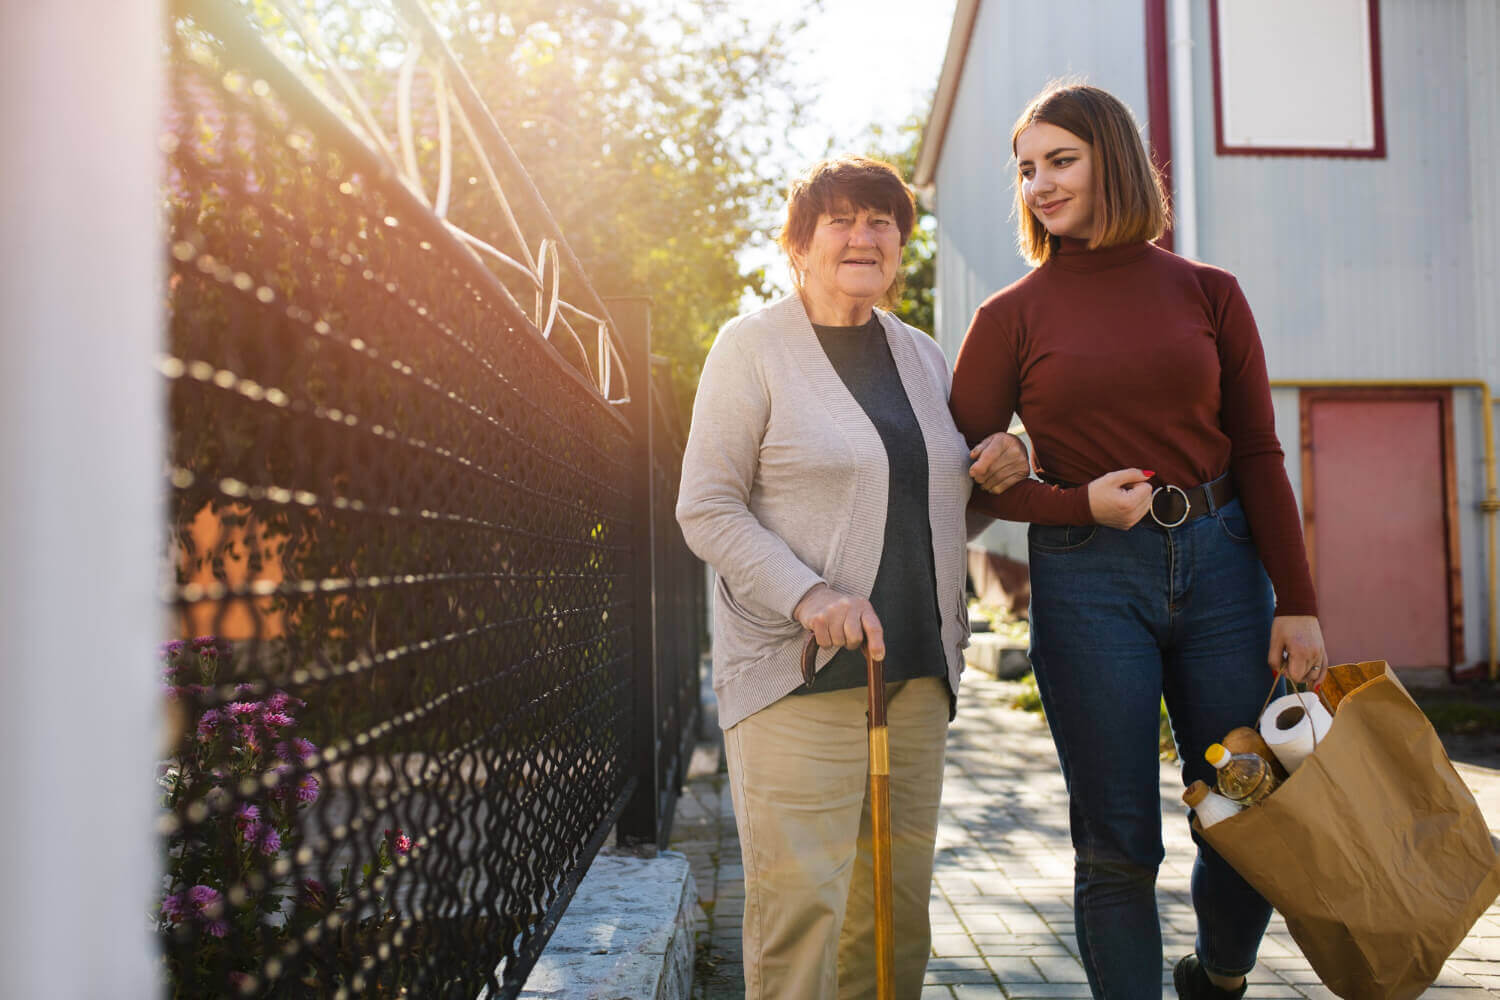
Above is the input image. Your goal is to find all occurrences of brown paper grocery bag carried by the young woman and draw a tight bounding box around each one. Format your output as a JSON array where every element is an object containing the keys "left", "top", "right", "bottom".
[{"left": 1196, "top": 660, "right": 1500, "bottom": 1000}]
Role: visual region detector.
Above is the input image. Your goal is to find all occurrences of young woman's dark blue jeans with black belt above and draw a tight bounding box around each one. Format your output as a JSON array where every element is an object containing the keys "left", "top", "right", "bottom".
[{"left": 1029, "top": 501, "right": 1274, "bottom": 1000}]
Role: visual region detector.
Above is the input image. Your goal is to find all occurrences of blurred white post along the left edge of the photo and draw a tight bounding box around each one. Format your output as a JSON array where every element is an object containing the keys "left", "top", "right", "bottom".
[{"left": 0, "top": 0, "right": 164, "bottom": 1000}]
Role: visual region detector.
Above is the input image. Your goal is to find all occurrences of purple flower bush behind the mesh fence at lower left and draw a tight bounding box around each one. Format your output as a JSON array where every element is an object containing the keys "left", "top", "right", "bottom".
[{"left": 153, "top": 636, "right": 413, "bottom": 997}]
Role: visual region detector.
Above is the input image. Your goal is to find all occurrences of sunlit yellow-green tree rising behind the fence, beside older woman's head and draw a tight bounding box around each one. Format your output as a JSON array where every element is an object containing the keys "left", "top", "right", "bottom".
[{"left": 429, "top": 0, "right": 803, "bottom": 413}]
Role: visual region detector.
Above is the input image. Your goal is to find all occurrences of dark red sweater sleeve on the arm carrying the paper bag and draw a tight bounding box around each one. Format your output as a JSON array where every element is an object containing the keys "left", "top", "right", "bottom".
[{"left": 1215, "top": 277, "right": 1317, "bottom": 615}]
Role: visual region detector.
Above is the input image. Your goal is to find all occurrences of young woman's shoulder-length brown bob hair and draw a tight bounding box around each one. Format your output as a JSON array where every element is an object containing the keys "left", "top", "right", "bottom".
[{"left": 1011, "top": 82, "right": 1169, "bottom": 267}]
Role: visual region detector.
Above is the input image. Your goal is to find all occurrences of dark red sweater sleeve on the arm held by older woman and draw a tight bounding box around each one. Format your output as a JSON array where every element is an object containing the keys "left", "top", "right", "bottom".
[{"left": 948, "top": 306, "right": 1094, "bottom": 525}]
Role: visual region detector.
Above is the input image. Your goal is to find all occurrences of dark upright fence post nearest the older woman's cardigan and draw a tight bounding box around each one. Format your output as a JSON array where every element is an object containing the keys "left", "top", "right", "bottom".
[{"left": 605, "top": 295, "right": 662, "bottom": 844}]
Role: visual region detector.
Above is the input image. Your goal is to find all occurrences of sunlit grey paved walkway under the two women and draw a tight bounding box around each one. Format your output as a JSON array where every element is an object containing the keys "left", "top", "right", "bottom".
[{"left": 672, "top": 670, "right": 1500, "bottom": 1000}]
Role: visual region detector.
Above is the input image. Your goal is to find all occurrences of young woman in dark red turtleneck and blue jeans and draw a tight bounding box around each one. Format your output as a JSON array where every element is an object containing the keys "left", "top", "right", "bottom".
[{"left": 951, "top": 84, "right": 1325, "bottom": 999}]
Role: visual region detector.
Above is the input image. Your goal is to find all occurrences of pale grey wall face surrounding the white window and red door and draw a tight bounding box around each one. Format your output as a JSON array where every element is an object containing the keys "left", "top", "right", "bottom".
[{"left": 1173, "top": 0, "right": 1500, "bottom": 663}]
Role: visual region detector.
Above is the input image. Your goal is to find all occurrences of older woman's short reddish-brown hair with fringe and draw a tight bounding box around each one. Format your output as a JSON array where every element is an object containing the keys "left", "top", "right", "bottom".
[{"left": 776, "top": 156, "right": 917, "bottom": 300}]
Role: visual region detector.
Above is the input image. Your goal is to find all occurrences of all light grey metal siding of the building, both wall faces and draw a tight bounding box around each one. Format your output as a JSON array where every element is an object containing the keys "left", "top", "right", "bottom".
[{"left": 936, "top": 0, "right": 1500, "bottom": 661}]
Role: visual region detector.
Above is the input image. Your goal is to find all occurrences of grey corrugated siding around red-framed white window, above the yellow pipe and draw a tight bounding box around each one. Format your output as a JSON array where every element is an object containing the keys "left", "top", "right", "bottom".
[{"left": 1193, "top": 0, "right": 1496, "bottom": 378}]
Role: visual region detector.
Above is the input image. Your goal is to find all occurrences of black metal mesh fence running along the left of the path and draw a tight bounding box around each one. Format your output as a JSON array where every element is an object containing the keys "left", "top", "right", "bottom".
[{"left": 156, "top": 0, "right": 704, "bottom": 997}]
